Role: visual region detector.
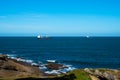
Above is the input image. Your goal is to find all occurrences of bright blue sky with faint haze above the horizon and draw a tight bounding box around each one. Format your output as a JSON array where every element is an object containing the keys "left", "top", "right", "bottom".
[{"left": 0, "top": 0, "right": 120, "bottom": 36}]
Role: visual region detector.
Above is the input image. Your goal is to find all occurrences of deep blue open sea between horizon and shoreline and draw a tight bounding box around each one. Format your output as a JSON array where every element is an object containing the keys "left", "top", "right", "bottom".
[{"left": 0, "top": 37, "right": 120, "bottom": 69}]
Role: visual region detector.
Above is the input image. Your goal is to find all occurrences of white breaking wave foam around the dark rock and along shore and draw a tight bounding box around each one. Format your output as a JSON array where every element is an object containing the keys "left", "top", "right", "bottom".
[{"left": 7, "top": 54, "right": 76, "bottom": 75}]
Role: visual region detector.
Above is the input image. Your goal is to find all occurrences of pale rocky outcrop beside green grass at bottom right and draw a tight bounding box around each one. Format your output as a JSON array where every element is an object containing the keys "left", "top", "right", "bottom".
[{"left": 84, "top": 68, "right": 120, "bottom": 80}]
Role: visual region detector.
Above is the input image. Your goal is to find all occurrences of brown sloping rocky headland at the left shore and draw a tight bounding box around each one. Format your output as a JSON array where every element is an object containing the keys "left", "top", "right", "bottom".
[{"left": 0, "top": 55, "right": 40, "bottom": 78}]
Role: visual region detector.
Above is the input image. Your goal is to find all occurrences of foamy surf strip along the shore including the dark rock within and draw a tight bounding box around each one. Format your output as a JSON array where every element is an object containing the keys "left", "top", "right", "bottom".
[{"left": 0, "top": 54, "right": 76, "bottom": 75}]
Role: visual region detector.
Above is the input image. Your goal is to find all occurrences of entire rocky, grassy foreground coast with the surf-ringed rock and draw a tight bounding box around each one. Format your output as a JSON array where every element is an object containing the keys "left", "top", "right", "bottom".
[{"left": 0, "top": 54, "right": 120, "bottom": 80}]
